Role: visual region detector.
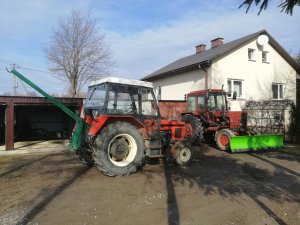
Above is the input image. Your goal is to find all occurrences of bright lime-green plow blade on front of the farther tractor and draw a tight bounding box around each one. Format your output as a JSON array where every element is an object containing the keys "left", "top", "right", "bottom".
[{"left": 230, "top": 134, "right": 284, "bottom": 153}]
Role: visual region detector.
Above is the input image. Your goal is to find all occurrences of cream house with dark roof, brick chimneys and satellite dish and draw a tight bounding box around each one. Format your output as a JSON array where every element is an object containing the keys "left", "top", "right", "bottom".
[{"left": 142, "top": 30, "right": 300, "bottom": 110}]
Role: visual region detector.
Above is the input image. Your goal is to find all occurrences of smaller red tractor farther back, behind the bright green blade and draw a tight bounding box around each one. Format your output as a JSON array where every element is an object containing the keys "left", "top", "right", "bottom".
[{"left": 182, "top": 89, "right": 247, "bottom": 151}]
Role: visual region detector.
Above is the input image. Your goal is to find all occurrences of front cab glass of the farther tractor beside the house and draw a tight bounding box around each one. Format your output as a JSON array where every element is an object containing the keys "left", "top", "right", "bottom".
[{"left": 207, "top": 92, "right": 227, "bottom": 111}]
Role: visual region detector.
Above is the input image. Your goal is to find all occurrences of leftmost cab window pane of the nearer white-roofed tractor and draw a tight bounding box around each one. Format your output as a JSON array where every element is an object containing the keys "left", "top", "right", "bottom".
[{"left": 84, "top": 84, "right": 106, "bottom": 111}]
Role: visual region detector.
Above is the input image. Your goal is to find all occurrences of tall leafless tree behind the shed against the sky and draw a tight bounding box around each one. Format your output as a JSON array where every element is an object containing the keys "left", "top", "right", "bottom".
[{"left": 44, "top": 10, "right": 112, "bottom": 97}]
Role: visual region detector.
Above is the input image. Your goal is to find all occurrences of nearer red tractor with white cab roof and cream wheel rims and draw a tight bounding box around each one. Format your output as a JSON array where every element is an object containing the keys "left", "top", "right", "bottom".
[{"left": 78, "top": 77, "right": 193, "bottom": 176}]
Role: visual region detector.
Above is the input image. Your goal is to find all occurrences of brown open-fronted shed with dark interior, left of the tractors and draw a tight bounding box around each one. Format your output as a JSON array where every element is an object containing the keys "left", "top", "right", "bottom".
[{"left": 0, "top": 96, "right": 83, "bottom": 150}]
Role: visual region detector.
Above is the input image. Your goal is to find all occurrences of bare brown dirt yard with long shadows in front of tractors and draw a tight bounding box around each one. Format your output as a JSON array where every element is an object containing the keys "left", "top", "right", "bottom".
[{"left": 0, "top": 145, "right": 300, "bottom": 225}]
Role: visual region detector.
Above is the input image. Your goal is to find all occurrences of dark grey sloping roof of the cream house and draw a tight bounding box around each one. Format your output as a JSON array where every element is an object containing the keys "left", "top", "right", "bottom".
[{"left": 141, "top": 30, "right": 300, "bottom": 81}]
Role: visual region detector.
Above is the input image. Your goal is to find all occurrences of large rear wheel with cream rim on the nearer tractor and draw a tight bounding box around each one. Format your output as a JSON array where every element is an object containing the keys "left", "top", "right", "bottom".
[{"left": 94, "top": 122, "right": 144, "bottom": 176}]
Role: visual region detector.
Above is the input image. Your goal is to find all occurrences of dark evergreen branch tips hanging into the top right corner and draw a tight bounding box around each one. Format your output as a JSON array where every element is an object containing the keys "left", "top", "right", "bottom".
[{"left": 239, "top": 0, "right": 300, "bottom": 15}]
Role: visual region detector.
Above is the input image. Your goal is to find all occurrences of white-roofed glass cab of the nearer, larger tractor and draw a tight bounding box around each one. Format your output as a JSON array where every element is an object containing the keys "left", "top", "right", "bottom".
[{"left": 84, "top": 77, "right": 160, "bottom": 123}]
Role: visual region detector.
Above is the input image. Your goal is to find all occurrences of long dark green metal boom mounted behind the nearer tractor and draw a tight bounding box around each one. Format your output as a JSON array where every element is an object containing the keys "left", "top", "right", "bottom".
[{"left": 8, "top": 69, "right": 90, "bottom": 151}]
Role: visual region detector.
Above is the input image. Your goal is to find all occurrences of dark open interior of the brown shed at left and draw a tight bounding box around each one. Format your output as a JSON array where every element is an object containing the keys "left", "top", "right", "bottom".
[{"left": 15, "top": 105, "right": 76, "bottom": 141}]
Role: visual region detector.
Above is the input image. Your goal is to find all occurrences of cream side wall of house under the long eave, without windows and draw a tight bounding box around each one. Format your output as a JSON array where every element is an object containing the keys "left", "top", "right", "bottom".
[{"left": 151, "top": 69, "right": 205, "bottom": 100}]
